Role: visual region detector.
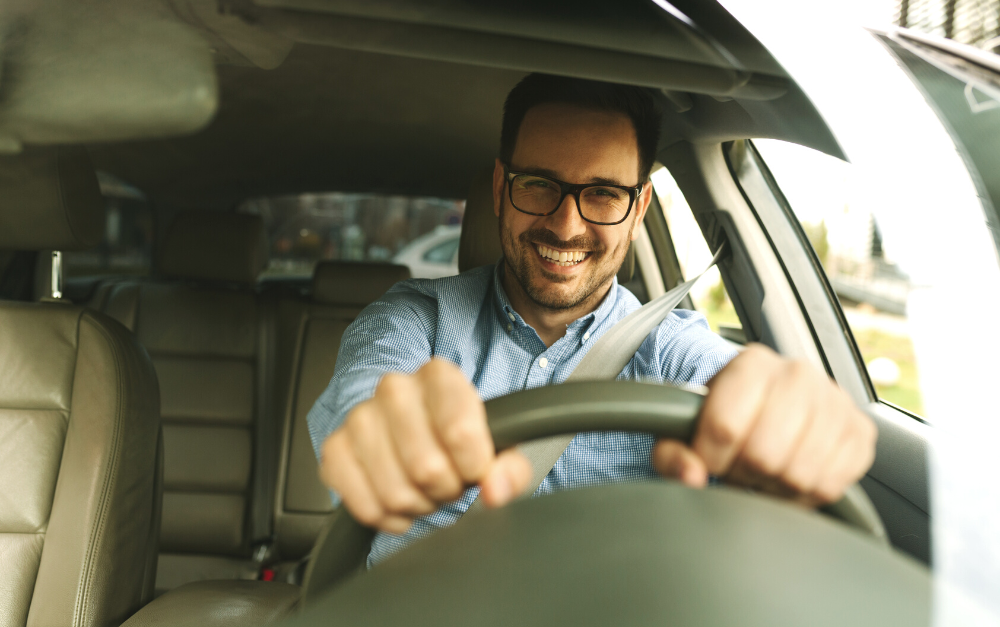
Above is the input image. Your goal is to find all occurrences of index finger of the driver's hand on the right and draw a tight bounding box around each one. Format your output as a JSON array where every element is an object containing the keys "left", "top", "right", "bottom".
[{"left": 691, "top": 344, "right": 781, "bottom": 475}]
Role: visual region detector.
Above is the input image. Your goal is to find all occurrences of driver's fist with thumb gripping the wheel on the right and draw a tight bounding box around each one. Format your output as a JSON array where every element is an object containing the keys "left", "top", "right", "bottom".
[{"left": 653, "top": 344, "right": 877, "bottom": 506}]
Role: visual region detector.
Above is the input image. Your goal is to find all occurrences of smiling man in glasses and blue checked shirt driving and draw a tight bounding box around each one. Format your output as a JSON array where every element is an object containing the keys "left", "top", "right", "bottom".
[{"left": 309, "top": 74, "right": 875, "bottom": 564}]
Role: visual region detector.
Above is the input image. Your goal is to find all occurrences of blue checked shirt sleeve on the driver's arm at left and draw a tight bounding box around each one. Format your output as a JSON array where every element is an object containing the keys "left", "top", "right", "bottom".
[{"left": 306, "top": 284, "right": 435, "bottom": 490}]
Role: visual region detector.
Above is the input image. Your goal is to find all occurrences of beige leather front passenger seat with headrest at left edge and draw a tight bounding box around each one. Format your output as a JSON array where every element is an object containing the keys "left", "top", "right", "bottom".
[{"left": 0, "top": 149, "right": 160, "bottom": 626}]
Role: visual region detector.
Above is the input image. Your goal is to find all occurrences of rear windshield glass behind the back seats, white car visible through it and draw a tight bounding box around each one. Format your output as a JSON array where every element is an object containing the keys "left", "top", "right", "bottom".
[{"left": 239, "top": 192, "right": 465, "bottom": 277}]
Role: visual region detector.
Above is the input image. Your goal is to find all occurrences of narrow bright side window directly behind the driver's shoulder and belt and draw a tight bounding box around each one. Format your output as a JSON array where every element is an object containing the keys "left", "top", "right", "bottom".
[{"left": 650, "top": 168, "right": 743, "bottom": 342}]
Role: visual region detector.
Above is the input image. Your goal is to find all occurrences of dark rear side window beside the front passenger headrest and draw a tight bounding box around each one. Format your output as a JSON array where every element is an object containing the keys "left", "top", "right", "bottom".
[{"left": 63, "top": 172, "right": 153, "bottom": 278}]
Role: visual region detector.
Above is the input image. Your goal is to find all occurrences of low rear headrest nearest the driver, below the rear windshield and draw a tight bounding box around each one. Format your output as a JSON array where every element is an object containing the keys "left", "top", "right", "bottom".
[{"left": 312, "top": 261, "right": 410, "bottom": 307}]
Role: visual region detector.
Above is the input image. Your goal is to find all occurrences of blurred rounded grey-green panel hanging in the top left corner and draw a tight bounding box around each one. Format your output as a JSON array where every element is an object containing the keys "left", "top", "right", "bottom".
[{"left": 0, "top": 0, "right": 218, "bottom": 154}]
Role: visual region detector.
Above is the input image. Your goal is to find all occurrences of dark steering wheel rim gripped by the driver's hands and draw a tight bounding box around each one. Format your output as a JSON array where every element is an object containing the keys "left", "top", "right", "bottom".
[{"left": 301, "top": 381, "right": 888, "bottom": 605}]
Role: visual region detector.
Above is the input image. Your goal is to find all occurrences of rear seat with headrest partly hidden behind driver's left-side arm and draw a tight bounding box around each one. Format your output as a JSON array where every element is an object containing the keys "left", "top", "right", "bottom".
[{"left": 274, "top": 262, "right": 410, "bottom": 560}]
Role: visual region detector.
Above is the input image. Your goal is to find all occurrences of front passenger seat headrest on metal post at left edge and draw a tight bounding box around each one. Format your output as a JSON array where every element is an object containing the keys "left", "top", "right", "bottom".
[{"left": 0, "top": 147, "right": 104, "bottom": 250}]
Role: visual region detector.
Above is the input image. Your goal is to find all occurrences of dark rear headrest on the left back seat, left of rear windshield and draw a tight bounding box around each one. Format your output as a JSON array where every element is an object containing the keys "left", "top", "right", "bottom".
[{"left": 159, "top": 211, "right": 268, "bottom": 285}]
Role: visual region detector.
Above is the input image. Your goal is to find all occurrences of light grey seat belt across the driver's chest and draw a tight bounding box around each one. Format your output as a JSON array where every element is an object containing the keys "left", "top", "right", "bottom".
[{"left": 466, "top": 244, "right": 725, "bottom": 513}]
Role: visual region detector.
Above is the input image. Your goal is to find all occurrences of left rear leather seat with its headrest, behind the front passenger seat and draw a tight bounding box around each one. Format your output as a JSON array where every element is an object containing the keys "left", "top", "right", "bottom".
[{"left": 105, "top": 211, "right": 280, "bottom": 590}]
